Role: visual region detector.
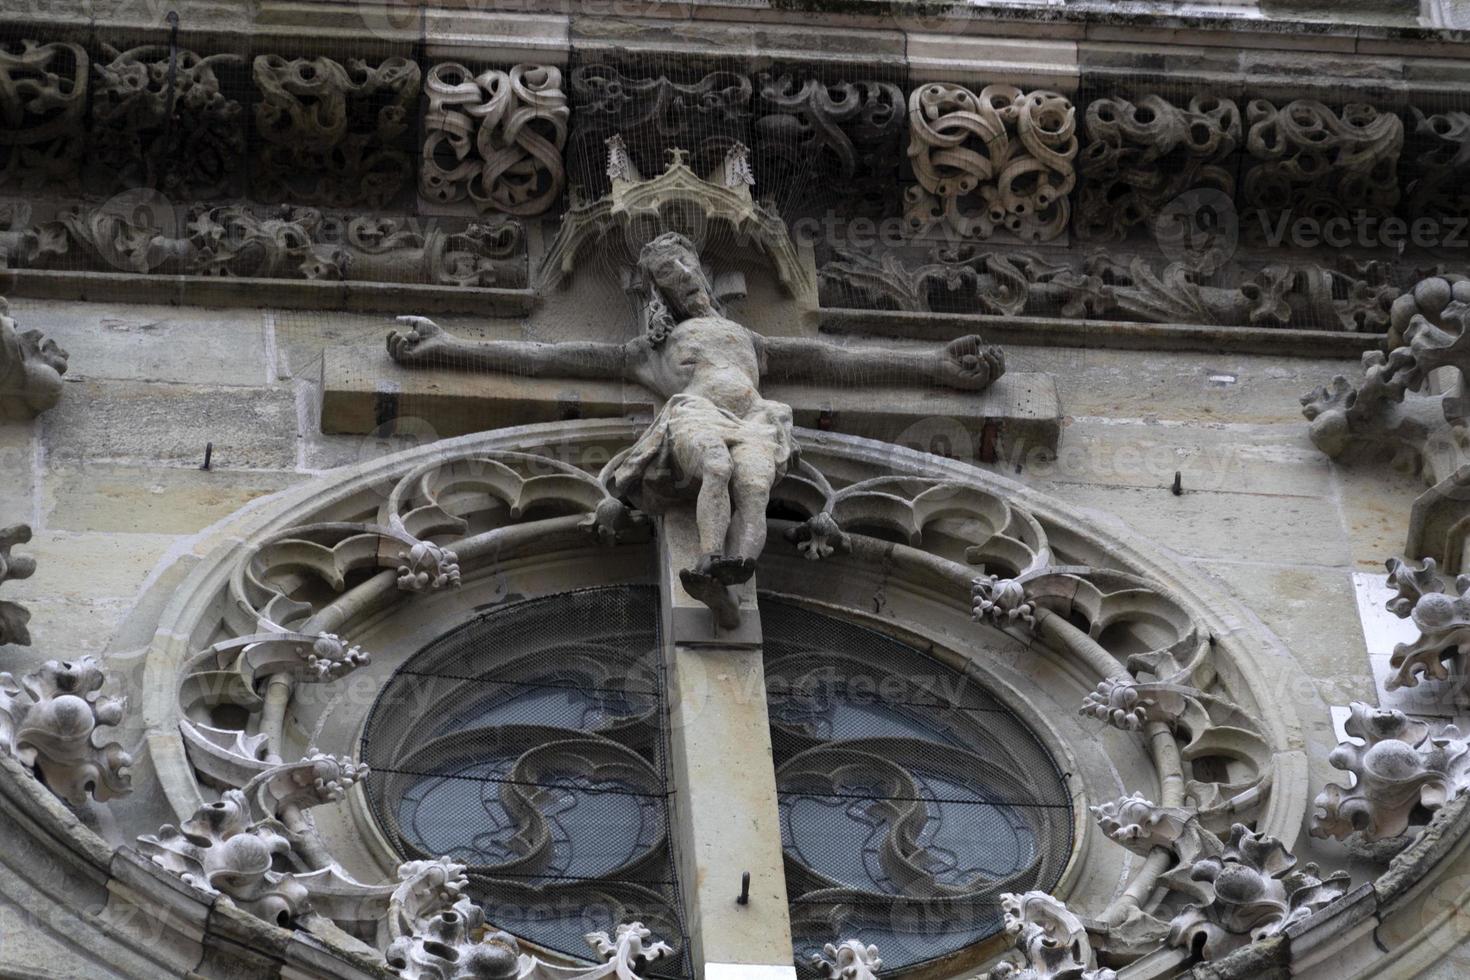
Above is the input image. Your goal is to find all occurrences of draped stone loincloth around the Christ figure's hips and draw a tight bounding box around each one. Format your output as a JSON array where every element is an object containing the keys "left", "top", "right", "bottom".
[{"left": 612, "top": 394, "right": 797, "bottom": 514}]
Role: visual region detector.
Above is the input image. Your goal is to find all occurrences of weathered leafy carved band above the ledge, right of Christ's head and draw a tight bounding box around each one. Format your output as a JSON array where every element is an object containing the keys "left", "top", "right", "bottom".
[{"left": 819, "top": 245, "right": 1398, "bottom": 331}]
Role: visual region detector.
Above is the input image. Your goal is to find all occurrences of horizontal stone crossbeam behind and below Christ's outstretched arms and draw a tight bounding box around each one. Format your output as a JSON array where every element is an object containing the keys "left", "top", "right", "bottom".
[{"left": 322, "top": 347, "right": 1061, "bottom": 460}]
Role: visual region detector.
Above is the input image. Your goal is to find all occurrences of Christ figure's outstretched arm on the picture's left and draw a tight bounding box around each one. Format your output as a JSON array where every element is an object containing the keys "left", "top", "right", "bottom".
[{"left": 388, "top": 316, "right": 647, "bottom": 381}]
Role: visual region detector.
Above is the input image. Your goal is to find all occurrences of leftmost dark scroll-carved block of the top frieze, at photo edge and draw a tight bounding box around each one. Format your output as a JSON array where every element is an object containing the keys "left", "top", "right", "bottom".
[{"left": 0, "top": 40, "right": 88, "bottom": 191}]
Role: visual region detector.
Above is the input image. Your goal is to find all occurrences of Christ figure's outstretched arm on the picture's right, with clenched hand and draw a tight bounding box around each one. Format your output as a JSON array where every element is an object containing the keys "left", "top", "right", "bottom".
[{"left": 757, "top": 334, "right": 1005, "bottom": 391}]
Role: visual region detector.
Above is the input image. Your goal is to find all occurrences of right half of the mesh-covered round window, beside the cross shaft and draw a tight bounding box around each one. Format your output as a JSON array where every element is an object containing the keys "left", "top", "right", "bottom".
[{"left": 761, "top": 597, "right": 1072, "bottom": 970}]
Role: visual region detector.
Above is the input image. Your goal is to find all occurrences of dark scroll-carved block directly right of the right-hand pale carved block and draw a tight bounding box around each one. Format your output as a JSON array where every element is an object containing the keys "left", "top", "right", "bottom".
[{"left": 1073, "top": 94, "right": 1241, "bottom": 241}]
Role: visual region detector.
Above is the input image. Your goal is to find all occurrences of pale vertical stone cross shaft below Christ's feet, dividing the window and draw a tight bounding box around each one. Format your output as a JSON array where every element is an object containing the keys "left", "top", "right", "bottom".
[{"left": 659, "top": 508, "right": 797, "bottom": 980}]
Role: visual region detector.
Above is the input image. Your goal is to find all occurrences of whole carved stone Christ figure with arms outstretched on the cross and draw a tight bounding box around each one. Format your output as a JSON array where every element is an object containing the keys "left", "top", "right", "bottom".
[{"left": 388, "top": 232, "right": 1005, "bottom": 623}]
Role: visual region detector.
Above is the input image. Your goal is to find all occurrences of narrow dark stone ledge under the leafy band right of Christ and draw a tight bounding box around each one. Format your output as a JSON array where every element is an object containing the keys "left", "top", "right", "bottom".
[{"left": 820, "top": 309, "right": 1385, "bottom": 360}]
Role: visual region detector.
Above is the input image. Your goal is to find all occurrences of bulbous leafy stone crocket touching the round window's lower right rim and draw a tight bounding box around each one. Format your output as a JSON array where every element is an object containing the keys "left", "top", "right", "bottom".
[{"left": 1161, "top": 824, "right": 1349, "bottom": 961}]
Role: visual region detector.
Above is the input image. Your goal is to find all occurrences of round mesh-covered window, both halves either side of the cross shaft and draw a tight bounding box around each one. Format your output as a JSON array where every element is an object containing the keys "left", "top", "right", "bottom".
[{"left": 354, "top": 586, "right": 1072, "bottom": 979}]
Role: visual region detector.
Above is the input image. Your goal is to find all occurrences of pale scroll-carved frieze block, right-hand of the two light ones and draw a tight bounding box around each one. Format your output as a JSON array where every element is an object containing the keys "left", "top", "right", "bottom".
[{"left": 906, "top": 82, "right": 1078, "bottom": 241}]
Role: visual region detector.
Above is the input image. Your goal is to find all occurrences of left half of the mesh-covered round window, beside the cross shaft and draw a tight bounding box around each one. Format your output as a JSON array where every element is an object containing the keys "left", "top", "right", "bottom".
[{"left": 362, "top": 586, "right": 689, "bottom": 979}]
